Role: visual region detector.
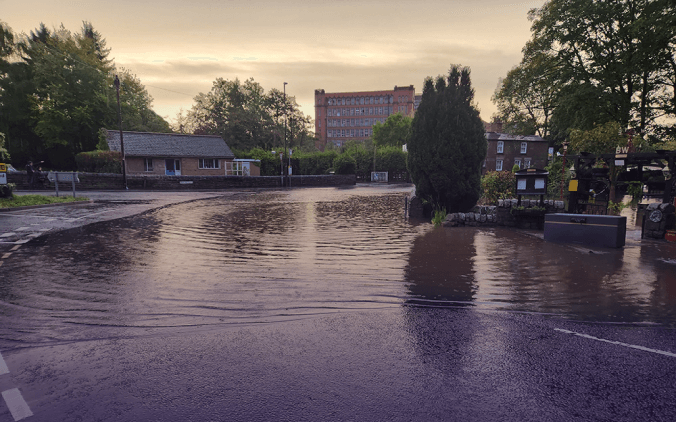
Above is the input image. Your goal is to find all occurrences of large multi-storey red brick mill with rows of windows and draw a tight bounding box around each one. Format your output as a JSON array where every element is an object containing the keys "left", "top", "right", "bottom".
[{"left": 315, "top": 85, "right": 416, "bottom": 149}]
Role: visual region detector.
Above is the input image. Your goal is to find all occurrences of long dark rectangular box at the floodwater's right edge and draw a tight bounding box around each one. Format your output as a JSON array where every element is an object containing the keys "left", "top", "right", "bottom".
[{"left": 545, "top": 214, "right": 627, "bottom": 248}]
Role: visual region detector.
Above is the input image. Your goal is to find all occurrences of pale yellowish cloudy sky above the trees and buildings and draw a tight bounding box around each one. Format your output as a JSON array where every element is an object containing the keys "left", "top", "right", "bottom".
[{"left": 0, "top": 0, "right": 544, "bottom": 121}]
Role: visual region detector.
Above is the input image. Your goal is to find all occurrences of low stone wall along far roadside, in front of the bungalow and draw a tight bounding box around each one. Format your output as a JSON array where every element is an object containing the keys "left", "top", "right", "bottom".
[{"left": 8, "top": 171, "right": 357, "bottom": 191}]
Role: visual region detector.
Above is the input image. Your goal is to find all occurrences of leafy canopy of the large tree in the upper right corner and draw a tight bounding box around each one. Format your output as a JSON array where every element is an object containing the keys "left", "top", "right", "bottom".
[{"left": 494, "top": 0, "right": 676, "bottom": 142}]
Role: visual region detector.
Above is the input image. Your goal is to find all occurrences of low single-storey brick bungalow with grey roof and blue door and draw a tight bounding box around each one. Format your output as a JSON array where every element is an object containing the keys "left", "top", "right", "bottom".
[{"left": 107, "top": 130, "right": 260, "bottom": 176}]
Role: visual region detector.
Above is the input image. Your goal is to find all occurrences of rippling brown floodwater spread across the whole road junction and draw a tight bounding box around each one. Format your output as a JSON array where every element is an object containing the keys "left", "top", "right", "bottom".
[{"left": 0, "top": 187, "right": 676, "bottom": 349}]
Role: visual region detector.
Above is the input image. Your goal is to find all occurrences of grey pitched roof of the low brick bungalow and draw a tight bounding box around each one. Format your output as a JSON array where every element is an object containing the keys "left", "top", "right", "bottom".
[{"left": 107, "top": 130, "right": 235, "bottom": 158}]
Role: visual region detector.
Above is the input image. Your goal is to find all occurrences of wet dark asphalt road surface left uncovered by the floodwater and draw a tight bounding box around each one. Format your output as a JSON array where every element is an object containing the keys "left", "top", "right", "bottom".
[{"left": 0, "top": 192, "right": 676, "bottom": 422}]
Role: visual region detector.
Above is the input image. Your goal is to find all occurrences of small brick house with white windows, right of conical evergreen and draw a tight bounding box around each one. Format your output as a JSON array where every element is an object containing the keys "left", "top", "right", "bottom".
[{"left": 481, "top": 132, "right": 549, "bottom": 174}]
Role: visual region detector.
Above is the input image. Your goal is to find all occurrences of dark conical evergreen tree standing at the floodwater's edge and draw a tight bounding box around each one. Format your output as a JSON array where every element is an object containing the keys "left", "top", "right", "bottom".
[{"left": 408, "top": 65, "right": 488, "bottom": 212}]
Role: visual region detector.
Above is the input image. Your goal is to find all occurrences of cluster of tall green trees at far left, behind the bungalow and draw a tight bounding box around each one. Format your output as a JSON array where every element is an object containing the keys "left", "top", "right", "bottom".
[{"left": 0, "top": 22, "right": 170, "bottom": 169}]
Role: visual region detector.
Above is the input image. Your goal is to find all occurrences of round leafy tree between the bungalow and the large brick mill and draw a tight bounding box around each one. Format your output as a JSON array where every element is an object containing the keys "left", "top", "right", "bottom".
[{"left": 177, "top": 78, "right": 314, "bottom": 150}]
